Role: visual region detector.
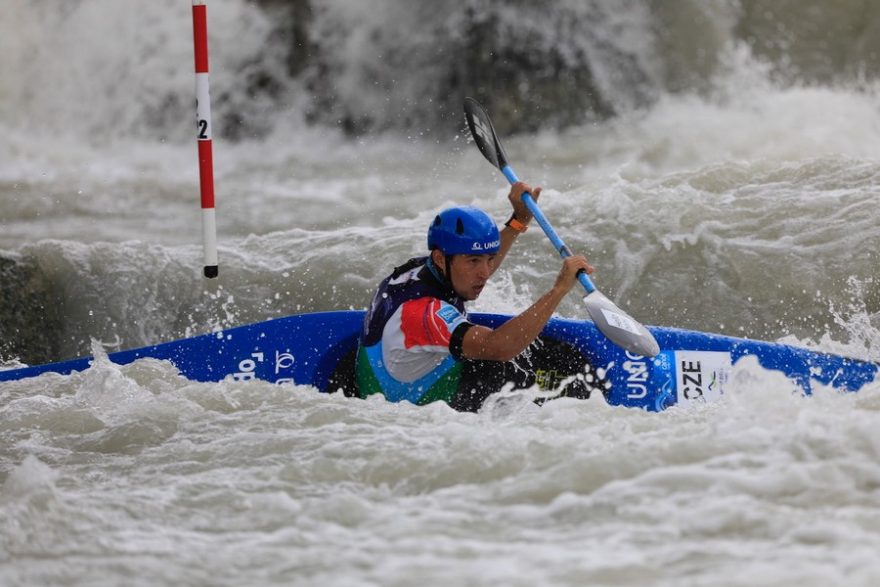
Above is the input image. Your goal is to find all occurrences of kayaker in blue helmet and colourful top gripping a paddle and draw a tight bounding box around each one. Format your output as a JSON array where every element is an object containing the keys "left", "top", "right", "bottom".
[{"left": 356, "top": 182, "right": 593, "bottom": 411}]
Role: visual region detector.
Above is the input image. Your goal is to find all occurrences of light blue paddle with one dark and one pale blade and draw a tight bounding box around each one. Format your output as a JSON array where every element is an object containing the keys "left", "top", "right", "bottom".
[{"left": 464, "top": 98, "right": 660, "bottom": 357}]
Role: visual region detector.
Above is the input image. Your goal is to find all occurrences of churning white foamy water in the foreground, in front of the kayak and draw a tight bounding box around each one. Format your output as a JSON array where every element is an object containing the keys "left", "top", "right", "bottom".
[{"left": 0, "top": 350, "right": 880, "bottom": 586}]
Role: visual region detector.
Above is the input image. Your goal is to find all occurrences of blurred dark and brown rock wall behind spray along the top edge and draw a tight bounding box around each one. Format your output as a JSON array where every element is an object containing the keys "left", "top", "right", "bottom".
[{"left": 180, "top": 0, "right": 880, "bottom": 139}]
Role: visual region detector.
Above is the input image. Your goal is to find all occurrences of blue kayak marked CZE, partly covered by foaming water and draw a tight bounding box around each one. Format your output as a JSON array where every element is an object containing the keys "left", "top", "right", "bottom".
[{"left": 0, "top": 311, "right": 880, "bottom": 411}]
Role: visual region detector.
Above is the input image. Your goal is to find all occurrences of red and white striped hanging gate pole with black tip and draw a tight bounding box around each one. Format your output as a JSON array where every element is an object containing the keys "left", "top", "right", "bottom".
[{"left": 193, "top": 0, "right": 218, "bottom": 278}]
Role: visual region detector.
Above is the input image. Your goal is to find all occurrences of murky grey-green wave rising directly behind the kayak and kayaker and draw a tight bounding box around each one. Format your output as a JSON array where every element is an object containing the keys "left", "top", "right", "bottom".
[{"left": 0, "top": 158, "right": 880, "bottom": 363}]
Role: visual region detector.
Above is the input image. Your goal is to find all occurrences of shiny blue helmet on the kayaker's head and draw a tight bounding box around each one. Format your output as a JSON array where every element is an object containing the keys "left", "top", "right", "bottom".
[{"left": 428, "top": 206, "right": 501, "bottom": 255}]
